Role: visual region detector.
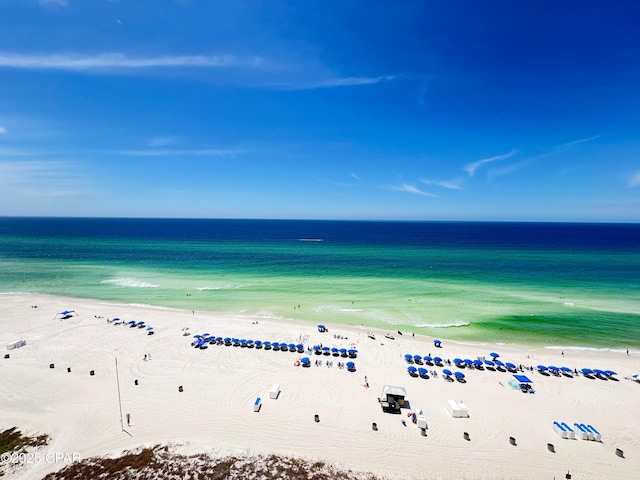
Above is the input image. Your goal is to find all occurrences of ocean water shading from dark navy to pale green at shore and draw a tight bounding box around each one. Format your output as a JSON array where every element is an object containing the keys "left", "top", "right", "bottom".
[{"left": 0, "top": 217, "right": 640, "bottom": 350}]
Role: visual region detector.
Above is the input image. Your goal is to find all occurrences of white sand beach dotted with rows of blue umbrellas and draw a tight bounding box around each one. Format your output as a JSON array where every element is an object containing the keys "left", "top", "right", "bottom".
[{"left": 0, "top": 294, "right": 640, "bottom": 480}]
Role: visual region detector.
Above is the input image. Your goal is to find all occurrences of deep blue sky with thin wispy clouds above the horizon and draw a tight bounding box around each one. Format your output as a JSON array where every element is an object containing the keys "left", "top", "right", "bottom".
[{"left": 0, "top": 0, "right": 640, "bottom": 222}]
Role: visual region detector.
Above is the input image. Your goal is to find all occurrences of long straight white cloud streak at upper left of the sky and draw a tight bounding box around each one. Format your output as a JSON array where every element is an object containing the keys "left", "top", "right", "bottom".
[{"left": 0, "top": 53, "right": 264, "bottom": 71}]
